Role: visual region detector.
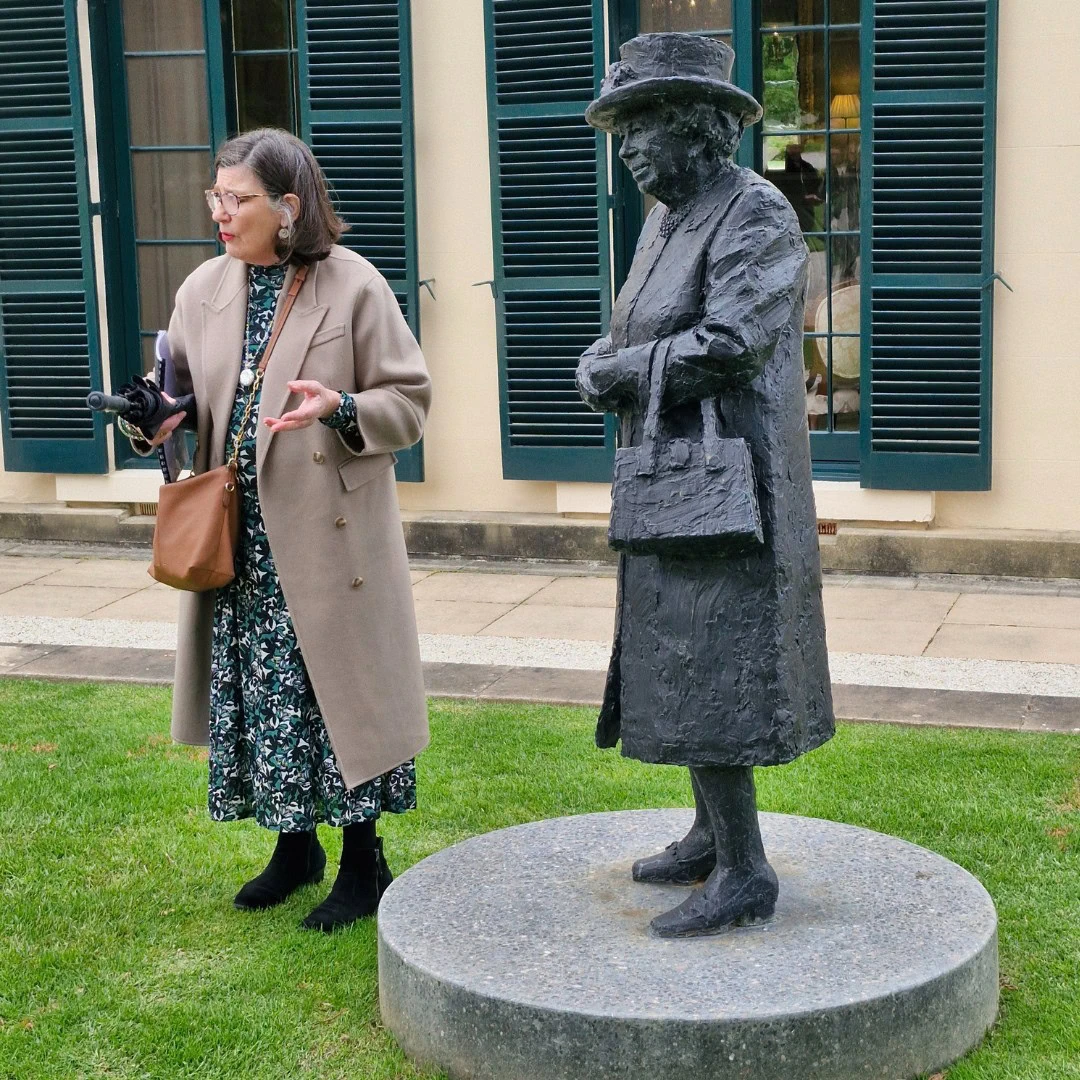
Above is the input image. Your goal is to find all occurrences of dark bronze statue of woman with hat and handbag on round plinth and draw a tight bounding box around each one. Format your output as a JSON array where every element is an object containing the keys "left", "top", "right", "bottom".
[{"left": 578, "top": 33, "right": 834, "bottom": 937}]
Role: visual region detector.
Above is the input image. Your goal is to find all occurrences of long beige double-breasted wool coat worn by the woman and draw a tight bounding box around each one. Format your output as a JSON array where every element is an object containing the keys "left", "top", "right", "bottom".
[{"left": 168, "top": 246, "right": 431, "bottom": 787}]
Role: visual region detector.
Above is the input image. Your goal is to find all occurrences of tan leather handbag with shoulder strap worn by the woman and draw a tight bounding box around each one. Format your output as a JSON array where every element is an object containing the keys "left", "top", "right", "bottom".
[{"left": 149, "top": 267, "right": 308, "bottom": 593}]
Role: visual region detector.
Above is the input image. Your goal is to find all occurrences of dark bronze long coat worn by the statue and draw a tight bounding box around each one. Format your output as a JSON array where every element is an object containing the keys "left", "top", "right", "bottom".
[{"left": 578, "top": 164, "right": 834, "bottom": 766}]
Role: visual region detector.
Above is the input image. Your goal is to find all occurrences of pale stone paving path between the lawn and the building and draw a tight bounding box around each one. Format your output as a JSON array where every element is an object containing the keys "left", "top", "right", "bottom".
[{"left": 0, "top": 542, "right": 1080, "bottom": 730}]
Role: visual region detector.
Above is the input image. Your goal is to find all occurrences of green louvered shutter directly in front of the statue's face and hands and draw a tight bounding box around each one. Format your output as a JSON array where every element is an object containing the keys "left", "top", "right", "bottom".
[{"left": 485, "top": 0, "right": 615, "bottom": 482}]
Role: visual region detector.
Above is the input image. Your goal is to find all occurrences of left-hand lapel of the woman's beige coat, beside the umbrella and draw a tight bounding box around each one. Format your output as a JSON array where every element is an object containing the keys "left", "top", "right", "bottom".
[{"left": 199, "top": 259, "right": 247, "bottom": 468}]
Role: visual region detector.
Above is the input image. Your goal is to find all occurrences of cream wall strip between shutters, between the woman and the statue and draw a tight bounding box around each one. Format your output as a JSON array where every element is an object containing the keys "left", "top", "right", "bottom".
[{"left": 397, "top": 0, "right": 555, "bottom": 513}]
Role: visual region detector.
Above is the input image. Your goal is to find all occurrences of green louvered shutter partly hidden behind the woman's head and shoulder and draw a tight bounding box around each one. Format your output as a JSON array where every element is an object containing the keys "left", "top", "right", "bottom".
[{"left": 297, "top": 0, "right": 423, "bottom": 482}]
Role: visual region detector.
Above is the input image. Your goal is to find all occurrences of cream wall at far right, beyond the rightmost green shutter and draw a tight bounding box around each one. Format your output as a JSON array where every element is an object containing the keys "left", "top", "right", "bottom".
[{"left": 936, "top": 0, "right": 1080, "bottom": 529}]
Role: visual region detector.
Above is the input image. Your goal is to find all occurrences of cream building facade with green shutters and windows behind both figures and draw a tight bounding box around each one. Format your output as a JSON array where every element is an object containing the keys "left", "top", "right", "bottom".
[{"left": 0, "top": 0, "right": 1080, "bottom": 530}]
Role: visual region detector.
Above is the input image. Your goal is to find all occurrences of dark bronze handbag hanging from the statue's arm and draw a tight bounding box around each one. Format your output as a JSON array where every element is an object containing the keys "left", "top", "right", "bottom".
[{"left": 608, "top": 343, "right": 765, "bottom": 557}]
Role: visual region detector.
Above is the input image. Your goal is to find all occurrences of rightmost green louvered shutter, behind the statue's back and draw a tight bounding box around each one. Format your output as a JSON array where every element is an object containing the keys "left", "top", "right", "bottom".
[{"left": 862, "top": 0, "right": 997, "bottom": 490}]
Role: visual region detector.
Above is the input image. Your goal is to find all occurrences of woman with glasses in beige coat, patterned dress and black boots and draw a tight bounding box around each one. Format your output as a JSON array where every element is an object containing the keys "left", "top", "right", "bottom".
[{"left": 137, "top": 129, "right": 431, "bottom": 931}]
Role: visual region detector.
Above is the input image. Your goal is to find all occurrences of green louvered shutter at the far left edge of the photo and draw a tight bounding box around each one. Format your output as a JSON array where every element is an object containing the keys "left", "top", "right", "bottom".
[{"left": 0, "top": 0, "right": 108, "bottom": 473}]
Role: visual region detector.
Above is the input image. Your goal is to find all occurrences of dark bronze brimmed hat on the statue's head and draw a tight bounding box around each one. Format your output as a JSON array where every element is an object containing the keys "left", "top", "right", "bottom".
[{"left": 585, "top": 33, "right": 761, "bottom": 132}]
